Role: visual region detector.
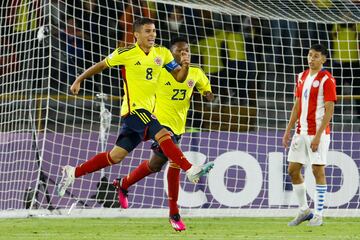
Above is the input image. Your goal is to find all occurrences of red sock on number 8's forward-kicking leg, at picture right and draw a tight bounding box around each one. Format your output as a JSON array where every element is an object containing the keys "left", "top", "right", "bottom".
[{"left": 159, "top": 138, "right": 192, "bottom": 171}]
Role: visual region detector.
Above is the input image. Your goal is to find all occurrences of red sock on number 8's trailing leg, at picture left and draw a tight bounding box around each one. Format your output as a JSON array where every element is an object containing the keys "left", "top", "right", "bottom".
[{"left": 75, "top": 152, "right": 114, "bottom": 178}]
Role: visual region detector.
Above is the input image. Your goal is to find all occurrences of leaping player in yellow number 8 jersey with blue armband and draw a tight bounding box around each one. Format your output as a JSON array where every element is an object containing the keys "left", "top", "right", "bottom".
[{"left": 57, "top": 18, "right": 213, "bottom": 199}]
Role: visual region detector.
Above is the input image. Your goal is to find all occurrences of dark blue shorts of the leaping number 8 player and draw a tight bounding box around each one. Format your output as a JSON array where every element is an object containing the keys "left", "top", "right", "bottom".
[{"left": 116, "top": 109, "right": 164, "bottom": 152}]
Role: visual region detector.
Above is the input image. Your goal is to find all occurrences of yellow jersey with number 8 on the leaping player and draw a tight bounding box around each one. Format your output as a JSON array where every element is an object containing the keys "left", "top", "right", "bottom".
[{"left": 105, "top": 43, "right": 179, "bottom": 116}]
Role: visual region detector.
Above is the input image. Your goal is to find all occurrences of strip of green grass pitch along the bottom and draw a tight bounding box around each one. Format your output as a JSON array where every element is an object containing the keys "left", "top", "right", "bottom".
[{"left": 0, "top": 218, "right": 360, "bottom": 240}]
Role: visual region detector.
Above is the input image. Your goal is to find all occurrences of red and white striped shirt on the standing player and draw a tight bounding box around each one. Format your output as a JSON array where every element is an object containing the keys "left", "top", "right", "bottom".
[{"left": 295, "top": 69, "right": 337, "bottom": 135}]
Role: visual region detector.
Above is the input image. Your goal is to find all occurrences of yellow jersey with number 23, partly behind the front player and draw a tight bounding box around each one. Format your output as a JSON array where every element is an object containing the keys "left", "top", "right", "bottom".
[{"left": 154, "top": 65, "right": 211, "bottom": 135}]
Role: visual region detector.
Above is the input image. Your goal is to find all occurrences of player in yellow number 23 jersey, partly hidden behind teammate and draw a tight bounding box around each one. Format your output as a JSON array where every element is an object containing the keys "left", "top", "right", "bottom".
[{"left": 114, "top": 38, "right": 214, "bottom": 231}]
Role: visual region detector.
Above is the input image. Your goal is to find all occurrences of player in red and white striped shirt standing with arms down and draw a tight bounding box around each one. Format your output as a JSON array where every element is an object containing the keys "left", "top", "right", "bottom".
[{"left": 283, "top": 44, "right": 337, "bottom": 226}]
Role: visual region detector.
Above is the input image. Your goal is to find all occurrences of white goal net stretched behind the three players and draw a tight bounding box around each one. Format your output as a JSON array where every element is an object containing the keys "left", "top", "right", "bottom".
[{"left": 0, "top": 0, "right": 360, "bottom": 217}]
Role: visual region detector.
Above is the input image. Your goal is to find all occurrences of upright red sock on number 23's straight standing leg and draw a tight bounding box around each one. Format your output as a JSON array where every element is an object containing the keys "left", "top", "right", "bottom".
[{"left": 167, "top": 163, "right": 180, "bottom": 216}]
